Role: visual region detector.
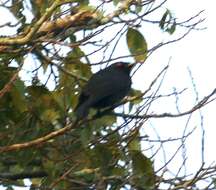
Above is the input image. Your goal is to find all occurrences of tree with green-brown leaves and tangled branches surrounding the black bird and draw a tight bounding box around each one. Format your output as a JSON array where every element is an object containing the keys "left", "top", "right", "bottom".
[{"left": 0, "top": 0, "right": 216, "bottom": 190}]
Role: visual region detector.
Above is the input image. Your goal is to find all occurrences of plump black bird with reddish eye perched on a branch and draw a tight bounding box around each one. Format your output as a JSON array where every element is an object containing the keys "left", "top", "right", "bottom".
[{"left": 75, "top": 62, "right": 134, "bottom": 119}]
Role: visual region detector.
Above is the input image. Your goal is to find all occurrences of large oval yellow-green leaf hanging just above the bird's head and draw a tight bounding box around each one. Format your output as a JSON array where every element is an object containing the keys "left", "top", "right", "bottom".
[{"left": 126, "top": 28, "right": 148, "bottom": 62}]
